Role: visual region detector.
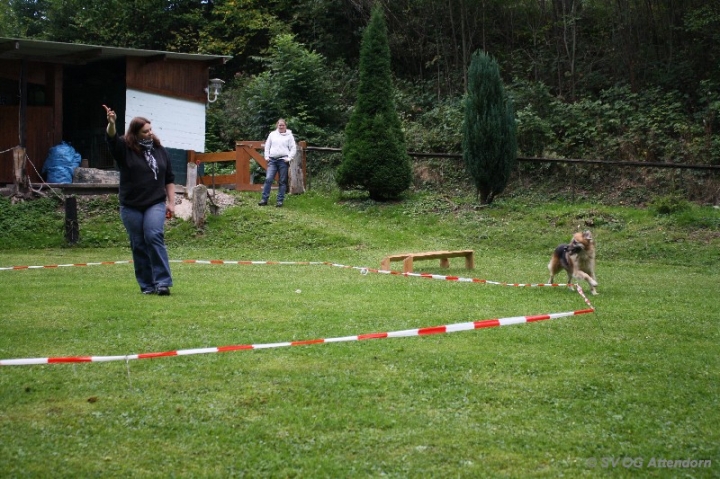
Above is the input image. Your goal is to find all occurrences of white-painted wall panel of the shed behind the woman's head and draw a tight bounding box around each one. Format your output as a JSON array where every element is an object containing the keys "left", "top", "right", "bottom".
[{"left": 125, "top": 90, "right": 205, "bottom": 153}]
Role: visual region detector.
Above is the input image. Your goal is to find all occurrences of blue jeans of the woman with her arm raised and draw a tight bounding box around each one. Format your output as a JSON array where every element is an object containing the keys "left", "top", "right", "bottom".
[{"left": 120, "top": 202, "right": 172, "bottom": 291}]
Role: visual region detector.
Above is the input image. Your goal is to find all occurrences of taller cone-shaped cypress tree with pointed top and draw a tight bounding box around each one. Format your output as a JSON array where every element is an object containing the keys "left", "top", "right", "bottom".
[{"left": 336, "top": 4, "right": 412, "bottom": 201}]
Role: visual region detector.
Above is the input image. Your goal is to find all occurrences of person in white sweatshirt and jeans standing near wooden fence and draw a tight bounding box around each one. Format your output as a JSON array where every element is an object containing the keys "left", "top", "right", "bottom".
[{"left": 258, "top": 118, "right": 297, "bottom": 208}]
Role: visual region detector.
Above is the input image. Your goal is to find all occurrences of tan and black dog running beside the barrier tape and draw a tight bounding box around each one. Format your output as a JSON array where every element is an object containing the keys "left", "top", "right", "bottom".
[{"left": 548, "top": 231, "right": 598, "bottom": 294}]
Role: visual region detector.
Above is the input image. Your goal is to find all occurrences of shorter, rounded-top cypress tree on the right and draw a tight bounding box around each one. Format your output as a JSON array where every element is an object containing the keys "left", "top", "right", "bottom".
[{"left": 463, "top": 50, "right": 517, "bottom": 204}]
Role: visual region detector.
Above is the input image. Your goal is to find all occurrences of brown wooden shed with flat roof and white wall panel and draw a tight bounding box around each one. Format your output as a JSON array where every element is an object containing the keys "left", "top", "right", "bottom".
[{"left": 0, "top": 37, "right": 231, "bottom": 185}]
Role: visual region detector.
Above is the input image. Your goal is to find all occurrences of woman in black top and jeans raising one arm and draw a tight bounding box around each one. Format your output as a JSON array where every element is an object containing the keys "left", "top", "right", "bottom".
[{"left": 103, "top": 105, "right": 175, "bottom": 296}]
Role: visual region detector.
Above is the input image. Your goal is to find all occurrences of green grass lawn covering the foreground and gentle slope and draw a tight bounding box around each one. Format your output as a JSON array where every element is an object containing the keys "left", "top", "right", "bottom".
[{"left": 0, "top": 193, "right": 720, "bottom": 478}]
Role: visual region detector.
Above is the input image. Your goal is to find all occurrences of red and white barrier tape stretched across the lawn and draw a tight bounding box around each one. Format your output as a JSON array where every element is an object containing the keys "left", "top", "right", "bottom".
[{"left": 0, "top": 260, "right": 595, "bottom": 366}]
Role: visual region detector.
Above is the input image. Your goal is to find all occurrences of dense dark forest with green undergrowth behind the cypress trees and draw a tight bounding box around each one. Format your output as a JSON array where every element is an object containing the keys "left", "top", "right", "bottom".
[{"left": 0, "top": 0, "right": 720, "bottom": 204}]
